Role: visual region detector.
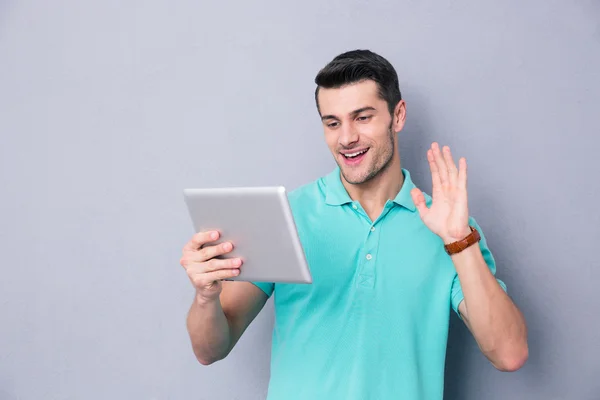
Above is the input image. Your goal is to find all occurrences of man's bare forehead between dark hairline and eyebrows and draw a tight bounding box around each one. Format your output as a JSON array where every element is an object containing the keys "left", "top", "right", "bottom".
[{"left": 318, "top": 81, "right": 385, "bottom": 116}]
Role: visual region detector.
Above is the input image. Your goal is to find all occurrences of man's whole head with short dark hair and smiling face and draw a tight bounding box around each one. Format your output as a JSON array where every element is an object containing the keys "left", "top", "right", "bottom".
[{"left": 315, "top": 50, "right": 405, "bottom": 184}]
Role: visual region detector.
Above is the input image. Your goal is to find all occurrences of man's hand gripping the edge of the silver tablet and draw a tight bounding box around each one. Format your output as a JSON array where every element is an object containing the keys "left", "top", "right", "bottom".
[{"left": 180, "top": 232, "right": 242, "bottom": 301}]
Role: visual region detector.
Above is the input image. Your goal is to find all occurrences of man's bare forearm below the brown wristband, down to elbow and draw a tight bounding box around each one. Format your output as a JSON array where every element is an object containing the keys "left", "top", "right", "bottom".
[{"left": 451, "top": 245, "right": 529, "bottom": 371}]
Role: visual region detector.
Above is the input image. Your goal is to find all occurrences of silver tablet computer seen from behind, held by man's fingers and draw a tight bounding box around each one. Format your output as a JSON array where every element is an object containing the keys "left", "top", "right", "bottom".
[{"left": 184, "top": 186, "right": 312, "bottom": 283}]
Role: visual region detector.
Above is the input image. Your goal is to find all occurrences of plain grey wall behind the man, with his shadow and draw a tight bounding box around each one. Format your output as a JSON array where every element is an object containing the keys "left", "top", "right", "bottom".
[{"left": 0, "top": 0, "right": 600, "bottom": 400}]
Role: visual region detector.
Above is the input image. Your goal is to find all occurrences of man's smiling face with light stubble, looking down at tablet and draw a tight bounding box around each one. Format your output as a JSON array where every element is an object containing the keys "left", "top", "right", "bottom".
[{"left": 318, "top": 80, "right": 404, "bottom": 184}]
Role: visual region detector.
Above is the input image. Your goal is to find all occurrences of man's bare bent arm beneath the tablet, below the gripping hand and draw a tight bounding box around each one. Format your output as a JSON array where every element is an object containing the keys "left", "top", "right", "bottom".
[{"left": 187, "top": 281, "right": 268, "bottom": 365}]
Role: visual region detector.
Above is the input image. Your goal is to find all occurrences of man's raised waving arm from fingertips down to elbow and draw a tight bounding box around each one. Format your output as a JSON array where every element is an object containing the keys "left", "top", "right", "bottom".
[{"left": 411, "top": 142, "right": 528, "bottom": 371}]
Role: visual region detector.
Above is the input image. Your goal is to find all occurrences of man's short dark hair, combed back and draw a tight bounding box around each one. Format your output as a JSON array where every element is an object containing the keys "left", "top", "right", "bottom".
[{"left": 315, "top": 50, "right": 402, "bottom": 115}]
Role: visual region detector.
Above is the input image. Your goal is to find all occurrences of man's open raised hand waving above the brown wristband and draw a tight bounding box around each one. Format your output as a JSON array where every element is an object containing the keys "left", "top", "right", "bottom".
[{"left": 410, "top": 142, "right": 471, "bottom": 244}]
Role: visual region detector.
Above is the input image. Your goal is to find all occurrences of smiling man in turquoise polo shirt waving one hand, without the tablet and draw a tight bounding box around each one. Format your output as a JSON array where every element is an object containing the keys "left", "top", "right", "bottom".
[{"left": 181, "top": 51, "right": 528, "bottom": 400}]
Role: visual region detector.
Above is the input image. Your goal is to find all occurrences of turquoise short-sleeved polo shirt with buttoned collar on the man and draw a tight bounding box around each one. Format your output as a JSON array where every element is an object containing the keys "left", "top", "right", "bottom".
[{"left": 255, "top": 168, "right": 506, "bottom": 400}]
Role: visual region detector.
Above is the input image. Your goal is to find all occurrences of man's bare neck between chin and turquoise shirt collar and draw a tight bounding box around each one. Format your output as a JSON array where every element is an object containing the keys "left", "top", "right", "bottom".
[{"left": 342, "top": 156, "right": 404, "bottom": 221}]
